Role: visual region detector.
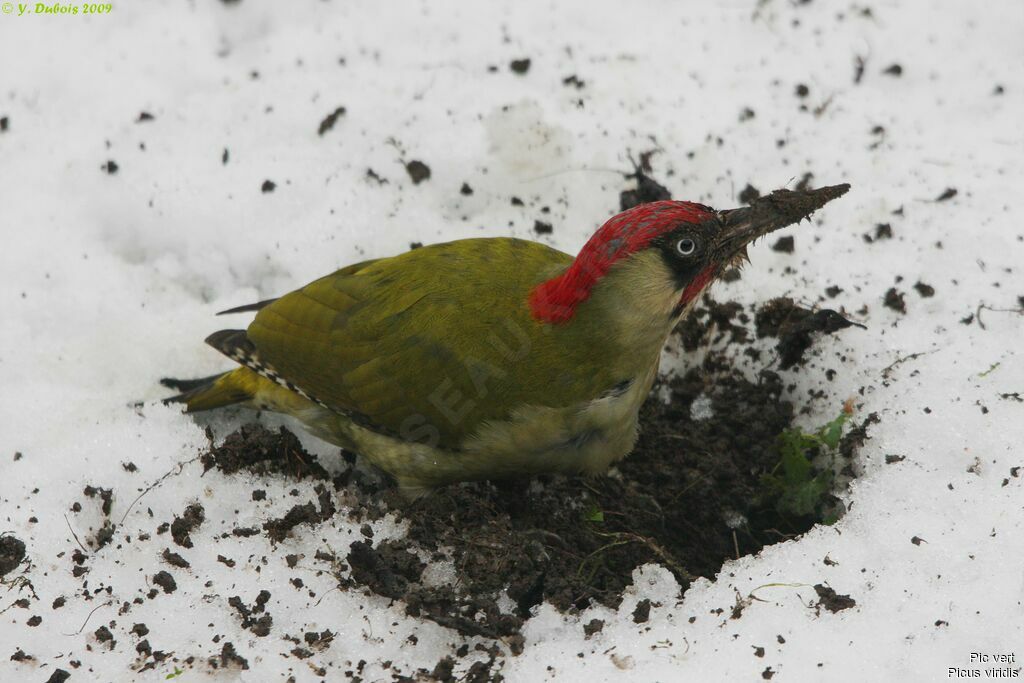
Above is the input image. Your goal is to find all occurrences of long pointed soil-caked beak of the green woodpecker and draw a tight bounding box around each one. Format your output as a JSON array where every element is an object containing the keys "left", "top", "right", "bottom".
[{"left": 715, "top": 183, "right": 850, "bottom": 265}]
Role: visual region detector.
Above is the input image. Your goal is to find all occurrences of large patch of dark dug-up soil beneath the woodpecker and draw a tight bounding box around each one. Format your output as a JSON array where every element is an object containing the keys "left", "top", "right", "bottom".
[{"left": 203, "top": 298, "right": 870, "bottom": 652}]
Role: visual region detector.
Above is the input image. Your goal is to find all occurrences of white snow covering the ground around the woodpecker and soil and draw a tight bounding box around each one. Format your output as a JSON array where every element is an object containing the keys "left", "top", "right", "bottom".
[{"left": 0, "top": 0, "right": 1024, "bottom": 681}]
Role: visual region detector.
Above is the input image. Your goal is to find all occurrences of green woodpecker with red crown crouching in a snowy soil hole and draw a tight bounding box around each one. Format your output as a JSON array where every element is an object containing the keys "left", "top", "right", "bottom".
[{"left": 162, "top": 184, "right": 850, "bottom": 498}]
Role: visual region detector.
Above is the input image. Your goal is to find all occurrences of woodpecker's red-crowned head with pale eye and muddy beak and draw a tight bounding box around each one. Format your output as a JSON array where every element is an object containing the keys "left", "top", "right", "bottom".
[{"left": 529, "top": 184, "right": 850, "bottom": 324}]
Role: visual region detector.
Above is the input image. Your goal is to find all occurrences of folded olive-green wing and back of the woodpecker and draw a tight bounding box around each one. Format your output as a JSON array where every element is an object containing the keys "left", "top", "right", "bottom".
[{"left": 248, "top": 239, "right": 621, "bottom": 447}]
